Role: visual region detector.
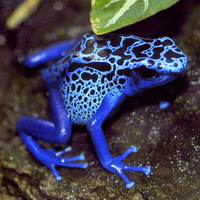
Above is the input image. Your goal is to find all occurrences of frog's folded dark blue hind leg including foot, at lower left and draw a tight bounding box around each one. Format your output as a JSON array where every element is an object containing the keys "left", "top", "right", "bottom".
[{"left": 17, "top": 85, "right": 88, "bottom": 180}]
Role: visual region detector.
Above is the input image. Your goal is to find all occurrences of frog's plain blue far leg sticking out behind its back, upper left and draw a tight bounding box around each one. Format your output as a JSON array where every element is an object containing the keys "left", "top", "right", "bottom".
[{"left": 24, "top": 38, "right": 80, "bottom": 68}]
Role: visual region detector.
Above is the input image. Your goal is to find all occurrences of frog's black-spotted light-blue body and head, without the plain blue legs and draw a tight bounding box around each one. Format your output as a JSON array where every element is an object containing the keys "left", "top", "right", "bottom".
[{"left": 44, "top": 33, "right": 187, "bottom": 125}]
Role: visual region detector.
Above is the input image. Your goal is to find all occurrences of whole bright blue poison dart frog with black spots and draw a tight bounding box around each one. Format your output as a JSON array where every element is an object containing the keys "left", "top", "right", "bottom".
[{"left": 17, "top": 33, "right": 187, "bottom": 188}]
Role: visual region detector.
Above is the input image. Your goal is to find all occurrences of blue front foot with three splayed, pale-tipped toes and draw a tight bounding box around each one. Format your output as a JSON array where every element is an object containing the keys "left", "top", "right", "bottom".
[{"left": 103, "top": 146, "right": 151, "bottom": 189}]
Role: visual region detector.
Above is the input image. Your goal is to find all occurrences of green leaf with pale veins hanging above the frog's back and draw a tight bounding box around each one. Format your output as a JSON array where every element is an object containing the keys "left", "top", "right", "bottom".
[{"left": 91, "top": 0, "right": 178, "bottom": 34}]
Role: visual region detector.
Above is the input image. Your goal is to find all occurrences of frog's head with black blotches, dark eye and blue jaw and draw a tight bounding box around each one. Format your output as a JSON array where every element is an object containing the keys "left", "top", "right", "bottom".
[{"left": 128, "top": 37, "right": 187, "bottom": 90}]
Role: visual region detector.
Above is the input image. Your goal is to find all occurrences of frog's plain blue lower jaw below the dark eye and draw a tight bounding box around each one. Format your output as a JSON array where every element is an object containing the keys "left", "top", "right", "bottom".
[{"left": 137, "top": 73, "right": 180, "bottom": 90}]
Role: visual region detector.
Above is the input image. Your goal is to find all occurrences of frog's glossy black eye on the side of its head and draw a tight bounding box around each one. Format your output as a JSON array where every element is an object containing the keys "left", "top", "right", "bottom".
[{"left": 134, "top": 65, "right": 158, "bottom": 79}]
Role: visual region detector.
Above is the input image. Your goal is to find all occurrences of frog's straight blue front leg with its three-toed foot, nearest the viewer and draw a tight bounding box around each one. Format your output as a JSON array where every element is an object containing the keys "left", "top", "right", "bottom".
[{"left": 87, "top": 91, "right": 151, "bottom": 188}]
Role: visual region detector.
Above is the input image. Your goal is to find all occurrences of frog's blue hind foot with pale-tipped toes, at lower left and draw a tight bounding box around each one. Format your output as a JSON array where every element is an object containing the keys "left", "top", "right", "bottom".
[{"left": 39, "top": 147, "right": 88, "bottom": 181}]
